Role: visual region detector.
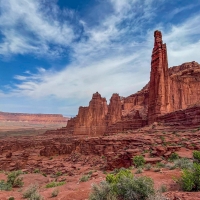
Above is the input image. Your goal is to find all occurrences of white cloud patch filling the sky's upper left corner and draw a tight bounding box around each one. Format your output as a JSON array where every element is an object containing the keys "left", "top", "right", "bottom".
[{"left": 0, "top": 0, "right": 75, "bottom": 56}]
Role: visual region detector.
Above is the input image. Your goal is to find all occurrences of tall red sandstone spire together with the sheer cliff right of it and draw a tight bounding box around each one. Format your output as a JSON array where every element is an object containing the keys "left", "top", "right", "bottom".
[{"left": 148, "top": 31, "right": 200, "bottom": 124}]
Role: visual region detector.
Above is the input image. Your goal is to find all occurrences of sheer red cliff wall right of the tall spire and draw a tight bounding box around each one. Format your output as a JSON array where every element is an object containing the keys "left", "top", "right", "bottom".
[{"left": 169, "top": 62, "right": 200, "bottom": 112}]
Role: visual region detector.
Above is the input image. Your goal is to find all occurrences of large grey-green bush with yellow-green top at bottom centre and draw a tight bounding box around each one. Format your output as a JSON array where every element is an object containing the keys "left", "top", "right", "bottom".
[{"left": 89, "top": 170, "right": 154, "bottom": 200}]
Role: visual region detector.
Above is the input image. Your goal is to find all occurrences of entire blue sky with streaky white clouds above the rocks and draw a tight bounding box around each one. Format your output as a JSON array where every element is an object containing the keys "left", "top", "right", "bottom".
[{"left": 0, "top": 0, "right": 200, "bottom": 116}]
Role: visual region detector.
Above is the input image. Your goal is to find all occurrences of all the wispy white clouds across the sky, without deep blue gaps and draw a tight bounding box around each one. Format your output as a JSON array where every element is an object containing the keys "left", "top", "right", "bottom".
[{"left": 0, "top": 0, "right": 200, "bottom": 114}]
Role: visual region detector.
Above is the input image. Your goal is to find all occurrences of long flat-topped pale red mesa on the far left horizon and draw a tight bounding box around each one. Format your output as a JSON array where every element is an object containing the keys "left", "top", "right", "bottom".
[{"left": 0, "top": 112, "right": 69, "bottom": 122}]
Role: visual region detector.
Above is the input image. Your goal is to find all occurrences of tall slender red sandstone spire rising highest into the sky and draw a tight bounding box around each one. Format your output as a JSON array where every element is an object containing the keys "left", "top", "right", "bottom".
[{"left": 148, "top": 31, "right": 169, "bottom": 124}]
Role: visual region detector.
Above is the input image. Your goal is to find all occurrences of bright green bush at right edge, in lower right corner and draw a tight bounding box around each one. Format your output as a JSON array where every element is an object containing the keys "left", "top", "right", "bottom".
[{"left": 178, "top": 163, "right": 200, "bottom": 192}]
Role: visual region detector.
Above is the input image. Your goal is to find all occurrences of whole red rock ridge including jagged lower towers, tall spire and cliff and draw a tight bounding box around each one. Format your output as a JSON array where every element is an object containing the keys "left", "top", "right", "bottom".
[{"left": 47, "top": 30, "right": 200, "bottom": 136}]
